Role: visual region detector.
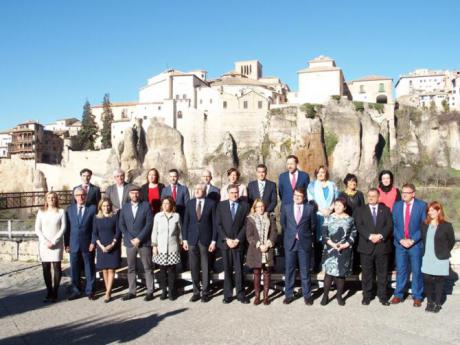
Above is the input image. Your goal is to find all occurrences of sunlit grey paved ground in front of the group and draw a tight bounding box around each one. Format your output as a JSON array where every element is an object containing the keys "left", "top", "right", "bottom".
[{"left": 0, "top": 263, "right": 460, "bottom": 345}]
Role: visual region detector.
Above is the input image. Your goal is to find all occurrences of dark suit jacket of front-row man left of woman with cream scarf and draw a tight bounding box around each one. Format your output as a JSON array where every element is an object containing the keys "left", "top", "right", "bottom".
[{"left": 216, "top": 200, "right": 249, "bottom": 251}]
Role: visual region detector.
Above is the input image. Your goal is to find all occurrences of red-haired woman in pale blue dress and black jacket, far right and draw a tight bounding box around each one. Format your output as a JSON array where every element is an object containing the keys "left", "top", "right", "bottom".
[{"left": 422, "top": 201, "right": 455, "bottom": 313}]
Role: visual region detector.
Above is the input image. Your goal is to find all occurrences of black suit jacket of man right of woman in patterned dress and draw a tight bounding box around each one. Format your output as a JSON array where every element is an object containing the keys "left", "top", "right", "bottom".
[{"left": 353, "top": 203, "right": 393, "bottom": 254}]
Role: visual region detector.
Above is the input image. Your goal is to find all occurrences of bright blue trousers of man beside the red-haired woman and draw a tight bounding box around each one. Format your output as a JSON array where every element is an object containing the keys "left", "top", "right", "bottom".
[{"left": 394, "top": 245, "right": 423, "bottom": 301}]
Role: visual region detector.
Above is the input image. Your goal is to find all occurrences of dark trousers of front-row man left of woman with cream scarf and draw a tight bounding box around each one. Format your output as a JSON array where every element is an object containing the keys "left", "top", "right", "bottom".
[{"left": 222, "top": 249, "right": 244, "bottom": 298}]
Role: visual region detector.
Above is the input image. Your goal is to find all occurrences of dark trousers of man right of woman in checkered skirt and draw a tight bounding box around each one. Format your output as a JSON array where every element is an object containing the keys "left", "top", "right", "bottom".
[{"left": 188, "top": 243, "right": 209, "bottom": 295}]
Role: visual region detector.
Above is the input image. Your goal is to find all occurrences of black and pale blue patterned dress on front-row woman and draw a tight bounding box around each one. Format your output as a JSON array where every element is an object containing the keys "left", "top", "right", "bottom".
[{"left": 322, "top": 214, "right": 357, "bottom": 277}]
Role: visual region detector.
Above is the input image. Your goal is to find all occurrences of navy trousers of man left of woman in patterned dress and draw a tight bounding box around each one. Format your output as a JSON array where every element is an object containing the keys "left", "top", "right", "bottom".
[{"left": 284, "top": 246, "right": 311, "bottom": 298}]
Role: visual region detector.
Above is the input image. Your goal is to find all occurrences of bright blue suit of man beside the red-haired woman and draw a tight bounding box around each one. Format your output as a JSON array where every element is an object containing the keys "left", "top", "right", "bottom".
[{"left": 393, "top": 199, "right": 427, "bottom": 301}]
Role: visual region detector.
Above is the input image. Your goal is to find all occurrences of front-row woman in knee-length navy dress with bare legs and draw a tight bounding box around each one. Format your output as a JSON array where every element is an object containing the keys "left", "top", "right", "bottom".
[{"left": 92, "top": 198, "right": 121, "bottom": 303}]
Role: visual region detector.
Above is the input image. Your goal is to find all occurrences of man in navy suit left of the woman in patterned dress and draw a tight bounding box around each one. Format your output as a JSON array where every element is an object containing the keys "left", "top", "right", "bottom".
[{"left": 281, "top": 188, "right": 316, "bottom": 305}]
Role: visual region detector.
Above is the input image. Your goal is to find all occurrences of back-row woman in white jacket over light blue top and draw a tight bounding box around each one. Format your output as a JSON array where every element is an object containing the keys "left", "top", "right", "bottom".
[{"left": 307, "top": 165, "right": 339, "bottom": 272}]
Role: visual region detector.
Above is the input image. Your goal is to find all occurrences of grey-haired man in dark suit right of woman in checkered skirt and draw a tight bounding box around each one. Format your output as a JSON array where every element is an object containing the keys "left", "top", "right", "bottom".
[{"left": 182, "top": 184, "right": 217, "bottom": 302}]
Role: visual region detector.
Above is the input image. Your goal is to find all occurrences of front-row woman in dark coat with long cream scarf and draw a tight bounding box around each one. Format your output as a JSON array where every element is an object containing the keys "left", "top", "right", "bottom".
[{"left": 246, "top": 199, "right": 278, "bottom": 305}]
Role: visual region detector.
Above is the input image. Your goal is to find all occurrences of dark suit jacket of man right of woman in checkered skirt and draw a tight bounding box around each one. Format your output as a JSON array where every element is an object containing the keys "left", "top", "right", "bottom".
[{"left": 182, "top": 198, "right": 217, "bottom": 246}]
